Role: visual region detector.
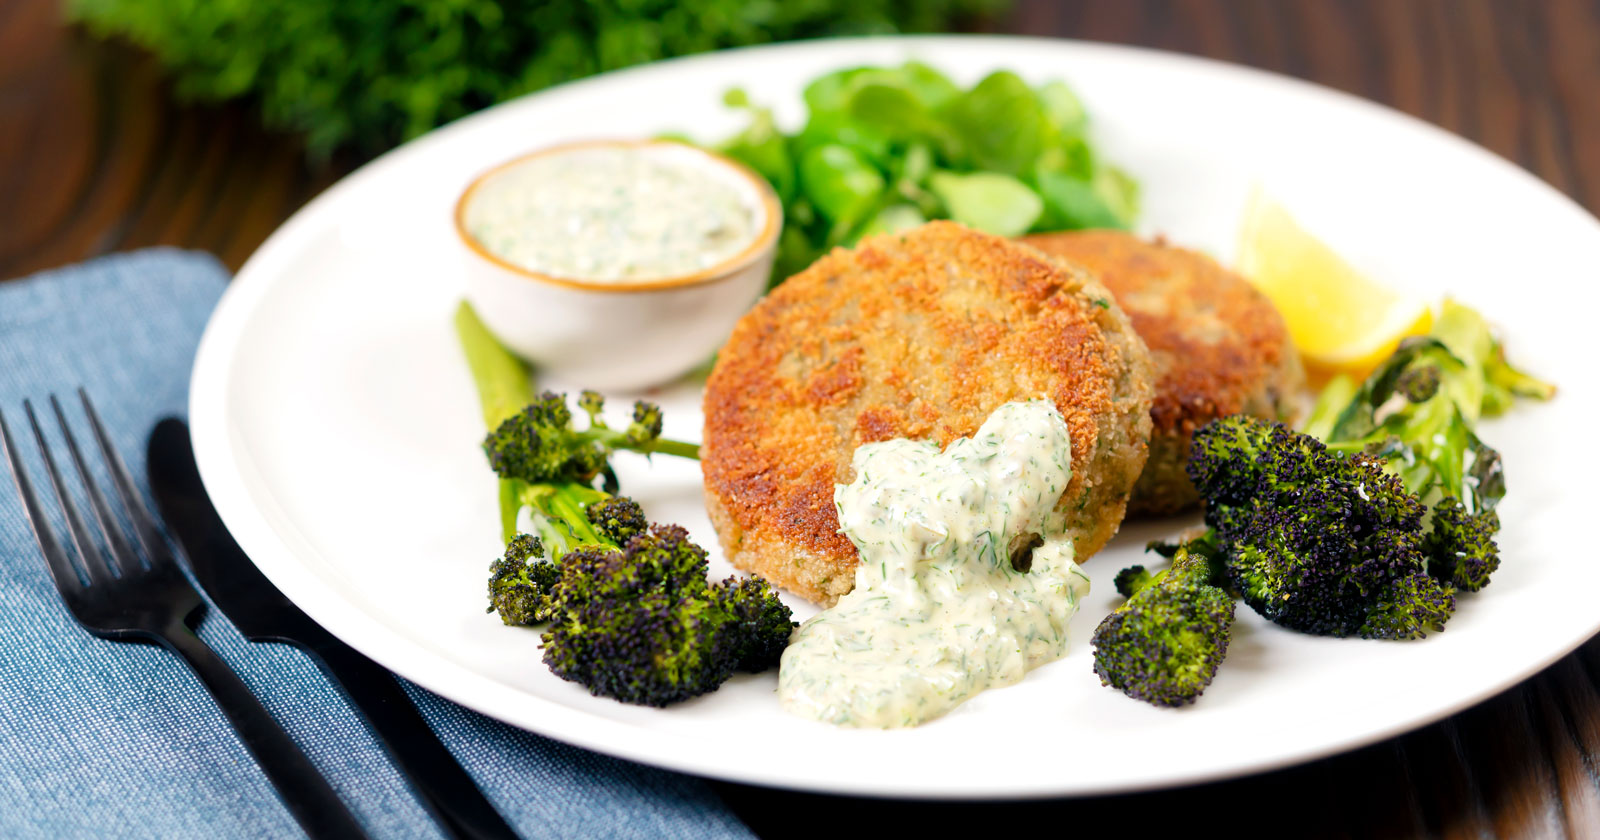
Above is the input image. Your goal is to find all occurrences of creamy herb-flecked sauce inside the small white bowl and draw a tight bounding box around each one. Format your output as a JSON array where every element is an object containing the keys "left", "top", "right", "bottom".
[{"left": 462, "top": 144, "right": 758, "bottom": 282}]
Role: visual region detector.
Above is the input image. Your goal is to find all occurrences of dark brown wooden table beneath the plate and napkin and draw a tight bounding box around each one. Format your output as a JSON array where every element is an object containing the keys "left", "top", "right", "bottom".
[{"left": 0, "top": 0, "right": 1600, "bottom": 838}]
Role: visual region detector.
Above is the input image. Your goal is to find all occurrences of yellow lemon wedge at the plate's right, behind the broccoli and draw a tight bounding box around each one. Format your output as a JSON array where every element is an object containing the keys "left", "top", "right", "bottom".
[{"left": 1238, "top": 189, "right": 1434, "bottom": 379}]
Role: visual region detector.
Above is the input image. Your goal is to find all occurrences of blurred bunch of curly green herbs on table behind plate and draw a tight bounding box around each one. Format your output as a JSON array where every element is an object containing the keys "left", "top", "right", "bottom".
[{"left": 75, "top": 0, "right": 1005, "bottom": 154}]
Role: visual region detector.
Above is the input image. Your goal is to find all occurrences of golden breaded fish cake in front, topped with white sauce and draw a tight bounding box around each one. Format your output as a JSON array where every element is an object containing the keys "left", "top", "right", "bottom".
[{"left": 701, "top": 222, "right": 1152, "bottom": 605}]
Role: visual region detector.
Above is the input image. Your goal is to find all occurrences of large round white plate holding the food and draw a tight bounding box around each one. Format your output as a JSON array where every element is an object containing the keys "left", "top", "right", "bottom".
[{"left": 190, "top": 38, "right": 1600, "bottom": 797}]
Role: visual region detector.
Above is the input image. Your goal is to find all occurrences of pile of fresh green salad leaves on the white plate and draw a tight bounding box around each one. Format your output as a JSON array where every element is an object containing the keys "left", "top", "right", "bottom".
[{"left": 715, "top": 61, "right": 1139, "bottom": 282}]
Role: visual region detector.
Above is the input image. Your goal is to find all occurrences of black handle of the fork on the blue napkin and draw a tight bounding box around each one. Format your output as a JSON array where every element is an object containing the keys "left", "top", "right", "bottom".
[{"left": 157, "top": 622, "right": 374, "bottom": 840}]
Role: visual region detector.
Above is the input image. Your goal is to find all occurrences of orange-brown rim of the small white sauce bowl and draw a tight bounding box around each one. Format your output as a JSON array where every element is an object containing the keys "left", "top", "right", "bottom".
[{"left": 453, "top": 139, "right": 784, "bottom": 293}]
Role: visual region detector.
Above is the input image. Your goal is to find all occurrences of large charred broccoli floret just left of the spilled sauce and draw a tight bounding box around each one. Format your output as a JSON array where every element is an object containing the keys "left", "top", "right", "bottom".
[{"left": 542, "top": 525, "right": 789, "bottom": 706}]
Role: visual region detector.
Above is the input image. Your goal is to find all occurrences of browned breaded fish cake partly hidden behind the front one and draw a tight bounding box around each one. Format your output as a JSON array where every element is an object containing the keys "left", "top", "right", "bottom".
[{"left": 1022, "top": 230, "right": 1306, "bottom": 514}]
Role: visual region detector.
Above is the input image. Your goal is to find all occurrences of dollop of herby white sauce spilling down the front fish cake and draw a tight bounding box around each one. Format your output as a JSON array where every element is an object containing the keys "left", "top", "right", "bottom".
[{"left": 778, "top": 400, "right": 1090, "bottom": 728}]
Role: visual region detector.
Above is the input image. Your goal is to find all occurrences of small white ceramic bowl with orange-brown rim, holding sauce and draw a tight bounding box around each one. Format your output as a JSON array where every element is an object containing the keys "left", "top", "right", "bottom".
[{"left": 454, "top": 141, "right": 782, "bottom": 390}]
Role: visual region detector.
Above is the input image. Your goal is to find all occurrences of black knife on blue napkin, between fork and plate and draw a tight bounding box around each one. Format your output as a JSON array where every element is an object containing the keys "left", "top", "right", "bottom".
[{"left": 147, "top": 418, "right": 517, "bottom": 840}]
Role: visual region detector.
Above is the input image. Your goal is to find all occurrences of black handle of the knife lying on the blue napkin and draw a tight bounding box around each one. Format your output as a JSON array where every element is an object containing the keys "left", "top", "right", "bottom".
[{"left": 299, "top": 635, "right": 517, "bottom": 840}]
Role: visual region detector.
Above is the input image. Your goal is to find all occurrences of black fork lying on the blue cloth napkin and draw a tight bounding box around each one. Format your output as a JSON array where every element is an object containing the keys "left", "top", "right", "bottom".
[{"left": 0, "top": 389, "right": 366, "bottom": 838}]
